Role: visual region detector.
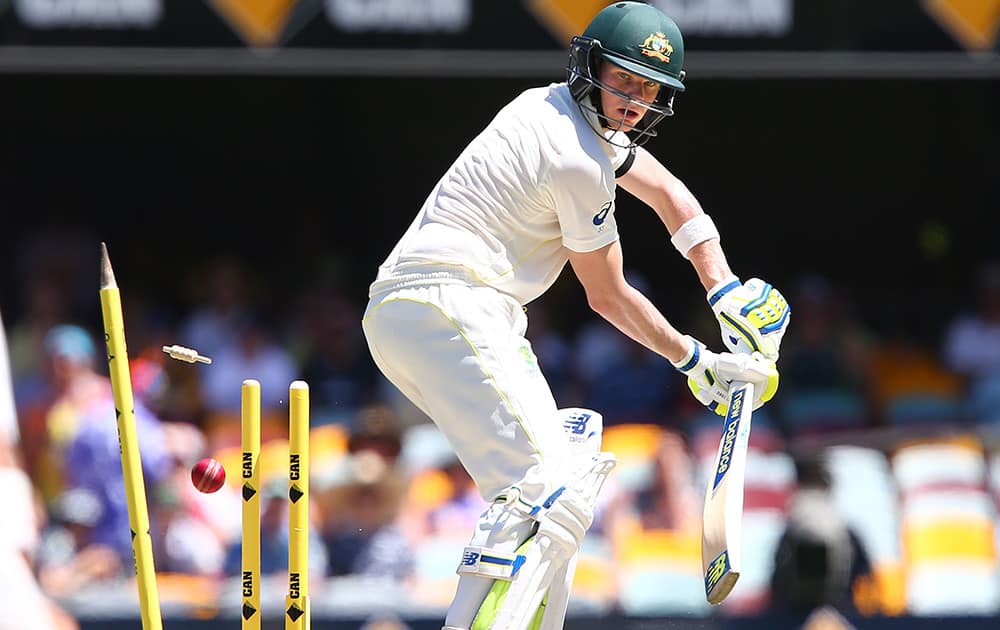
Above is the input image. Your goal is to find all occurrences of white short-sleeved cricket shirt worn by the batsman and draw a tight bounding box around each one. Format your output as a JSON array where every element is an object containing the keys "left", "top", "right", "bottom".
[{"left": 370, "top": 83, "right": 631, "bottom": 304}]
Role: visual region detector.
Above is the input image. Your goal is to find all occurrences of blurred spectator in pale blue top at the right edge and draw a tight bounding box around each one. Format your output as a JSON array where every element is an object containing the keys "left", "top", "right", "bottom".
[{"left": 944, "top": 261, "right": 1000, "bottom": 422}]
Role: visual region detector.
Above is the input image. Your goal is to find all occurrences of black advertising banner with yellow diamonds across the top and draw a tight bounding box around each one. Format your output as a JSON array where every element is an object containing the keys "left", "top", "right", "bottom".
[{"left": 0, "top": 0, "right": 1000, "bottom": 52}]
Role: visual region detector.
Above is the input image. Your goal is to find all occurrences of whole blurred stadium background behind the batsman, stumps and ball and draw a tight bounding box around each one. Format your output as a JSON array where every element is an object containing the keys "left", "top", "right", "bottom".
[{"left": 0, "top": 0, "right": 1000, "bottom": 630}]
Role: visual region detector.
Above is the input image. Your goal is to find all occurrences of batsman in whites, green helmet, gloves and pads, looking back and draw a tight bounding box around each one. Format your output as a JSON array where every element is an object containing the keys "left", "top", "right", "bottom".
[{"left": 362, "top": 2, "right": 789, "bottom": 630}]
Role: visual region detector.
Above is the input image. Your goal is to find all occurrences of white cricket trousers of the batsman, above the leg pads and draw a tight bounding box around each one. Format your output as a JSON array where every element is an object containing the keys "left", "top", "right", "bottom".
[{"left": 362, "top": 279, "right": 568, "bottom": 501}]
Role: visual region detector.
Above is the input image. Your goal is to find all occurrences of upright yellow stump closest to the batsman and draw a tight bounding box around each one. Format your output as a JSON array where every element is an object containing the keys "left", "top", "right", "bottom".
[{"left": 285, "top": 381, "right": 311, "bottom": 630}]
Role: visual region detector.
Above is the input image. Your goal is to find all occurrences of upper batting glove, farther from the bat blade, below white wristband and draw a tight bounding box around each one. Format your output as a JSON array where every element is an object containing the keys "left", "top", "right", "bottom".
[{"left": 708, "top": 278, "right": 792, "bottom": 361}]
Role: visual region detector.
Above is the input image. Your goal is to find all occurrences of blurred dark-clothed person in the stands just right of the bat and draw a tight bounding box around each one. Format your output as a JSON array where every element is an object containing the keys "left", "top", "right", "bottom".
[{"left": 771, "top": 456, "right": 872, "bottom": 627}]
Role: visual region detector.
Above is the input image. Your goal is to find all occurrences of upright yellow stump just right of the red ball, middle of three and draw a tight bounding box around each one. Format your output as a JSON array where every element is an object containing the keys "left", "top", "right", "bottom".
[{"left": 240, "top": 379, "right": 261, "bottom": 630}]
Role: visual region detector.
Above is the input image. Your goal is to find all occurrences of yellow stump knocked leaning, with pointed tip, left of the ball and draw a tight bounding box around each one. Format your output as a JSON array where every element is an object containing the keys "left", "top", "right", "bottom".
[{"left": 101, "top": 243, "right": 163, "bottom": 630}]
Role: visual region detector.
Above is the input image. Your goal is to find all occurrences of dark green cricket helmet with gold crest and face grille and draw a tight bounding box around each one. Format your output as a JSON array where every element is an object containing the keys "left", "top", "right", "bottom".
[{"left": 566, "top": 2, "right": 685, "bottom": 144}]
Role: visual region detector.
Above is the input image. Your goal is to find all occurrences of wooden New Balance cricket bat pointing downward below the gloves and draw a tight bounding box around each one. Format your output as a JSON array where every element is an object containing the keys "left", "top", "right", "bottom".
[{"left": 701, "top": 382, "right": 754, "bottom": 605}]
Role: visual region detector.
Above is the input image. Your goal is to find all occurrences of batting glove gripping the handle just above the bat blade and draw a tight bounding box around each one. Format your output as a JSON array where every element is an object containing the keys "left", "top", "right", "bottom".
[{"left": 672, "top": 336, "right": 778, "bottom": 416}]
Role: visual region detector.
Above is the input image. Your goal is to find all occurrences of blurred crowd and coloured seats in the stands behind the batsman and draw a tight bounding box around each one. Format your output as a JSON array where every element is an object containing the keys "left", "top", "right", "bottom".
[{"left": 0, "top": 231, "right": 1000, "bottom": 629}]
